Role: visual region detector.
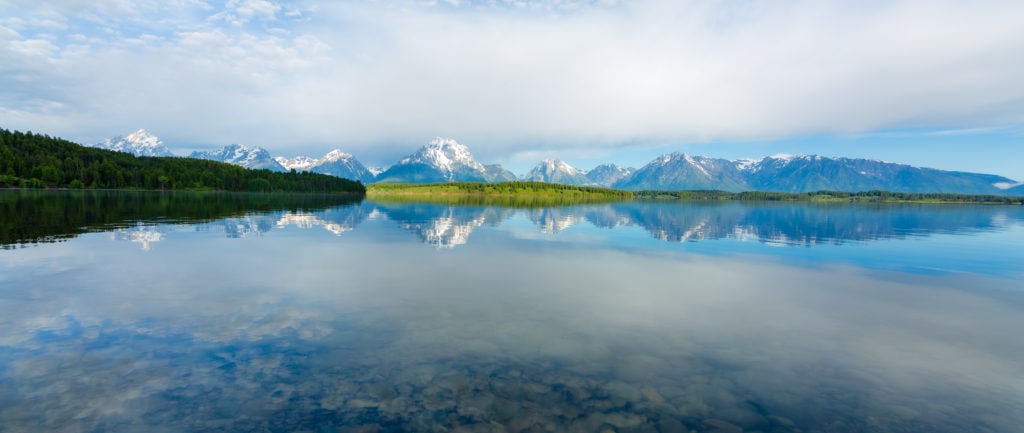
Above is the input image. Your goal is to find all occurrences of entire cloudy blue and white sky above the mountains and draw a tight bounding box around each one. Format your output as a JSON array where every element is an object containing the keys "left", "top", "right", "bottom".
[{"left": 0, "top": 0, "right": 1024, "bottom": 181}]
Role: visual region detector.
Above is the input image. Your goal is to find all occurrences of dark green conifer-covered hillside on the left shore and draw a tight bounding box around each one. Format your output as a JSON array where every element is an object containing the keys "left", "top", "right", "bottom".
[{"left": 0, "top": 128, "right": 366, "bottom": 193}]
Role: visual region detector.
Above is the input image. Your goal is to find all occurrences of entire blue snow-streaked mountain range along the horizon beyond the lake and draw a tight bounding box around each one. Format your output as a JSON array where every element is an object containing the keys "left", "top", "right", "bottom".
[{"left": 95, "top": 129, "right": 1024, "bottom": 196}]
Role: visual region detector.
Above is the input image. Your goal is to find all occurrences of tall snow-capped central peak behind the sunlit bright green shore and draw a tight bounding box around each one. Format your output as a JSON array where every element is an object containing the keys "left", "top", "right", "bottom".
[{"left": 377, "top": 137, "right": 509, "bottom": 183}]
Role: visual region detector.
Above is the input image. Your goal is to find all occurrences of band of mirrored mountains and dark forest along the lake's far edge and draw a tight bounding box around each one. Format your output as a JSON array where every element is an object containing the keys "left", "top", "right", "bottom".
[{"left": 6, "top": 192, "right": 1024, "bottom": 248}]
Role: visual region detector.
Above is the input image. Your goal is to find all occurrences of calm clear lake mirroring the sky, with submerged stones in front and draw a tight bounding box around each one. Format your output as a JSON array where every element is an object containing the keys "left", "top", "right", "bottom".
[{"left": 0, "top": 191, "right": 1024, "bottom": 433}]
